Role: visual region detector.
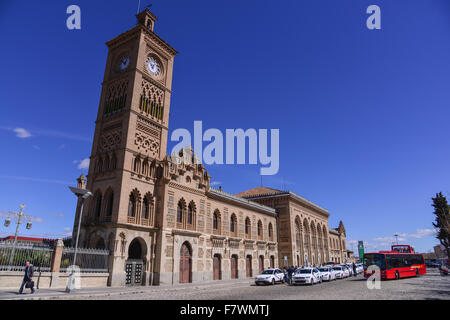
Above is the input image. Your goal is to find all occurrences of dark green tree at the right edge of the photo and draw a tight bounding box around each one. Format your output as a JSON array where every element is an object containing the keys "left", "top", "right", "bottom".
[{"left": 431, "top": 192, "right": 450, "bottom": 257}]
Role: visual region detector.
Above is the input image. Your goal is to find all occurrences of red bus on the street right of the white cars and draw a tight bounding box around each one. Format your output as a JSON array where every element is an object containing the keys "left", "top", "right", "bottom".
[{"left": 364, "top": 245, "right": 427, "bottom": 279}]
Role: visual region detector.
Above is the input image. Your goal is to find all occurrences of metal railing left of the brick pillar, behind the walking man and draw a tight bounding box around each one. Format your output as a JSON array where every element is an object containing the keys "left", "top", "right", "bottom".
[{"left": 0, "top": 243, "right": 54, "bottom": 272}]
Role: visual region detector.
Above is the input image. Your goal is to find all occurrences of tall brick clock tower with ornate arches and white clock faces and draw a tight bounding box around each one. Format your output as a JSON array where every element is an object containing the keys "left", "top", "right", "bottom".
[{"left": 74, "top": 9, "right": 177, "bottom": 286}]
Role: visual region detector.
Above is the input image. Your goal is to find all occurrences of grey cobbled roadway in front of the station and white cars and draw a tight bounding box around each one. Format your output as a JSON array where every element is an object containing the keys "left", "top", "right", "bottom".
[{"left": 65, "top": 269, "right": 450, "bottom": 300}]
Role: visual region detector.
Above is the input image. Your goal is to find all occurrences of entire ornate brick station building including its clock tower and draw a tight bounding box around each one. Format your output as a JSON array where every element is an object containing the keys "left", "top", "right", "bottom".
[{"left": 73, "top": 9, "right": 345, "bottom": 286}]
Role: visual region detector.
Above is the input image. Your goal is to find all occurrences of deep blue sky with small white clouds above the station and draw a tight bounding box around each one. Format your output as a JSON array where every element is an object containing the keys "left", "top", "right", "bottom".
[{"left": 0, "top": 0, "right": 450, "bottom": 255}]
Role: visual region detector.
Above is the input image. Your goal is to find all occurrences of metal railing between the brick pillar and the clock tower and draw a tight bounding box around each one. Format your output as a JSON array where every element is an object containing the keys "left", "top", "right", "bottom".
[{"left": 60, "top": 247, "right": 109, "bottom": 272}]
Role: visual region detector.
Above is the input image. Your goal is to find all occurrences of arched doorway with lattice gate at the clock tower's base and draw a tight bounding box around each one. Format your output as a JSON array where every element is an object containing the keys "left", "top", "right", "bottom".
[{"left": 125, "top": 238, "right": 147, "bottom": 286}]
